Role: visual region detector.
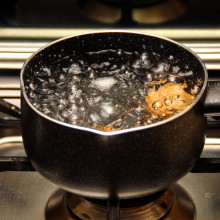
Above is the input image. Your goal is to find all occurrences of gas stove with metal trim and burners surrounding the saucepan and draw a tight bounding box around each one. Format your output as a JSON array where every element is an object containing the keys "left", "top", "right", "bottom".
[{"left": 0, "top": 0, "right": 220, "bottom": 220}]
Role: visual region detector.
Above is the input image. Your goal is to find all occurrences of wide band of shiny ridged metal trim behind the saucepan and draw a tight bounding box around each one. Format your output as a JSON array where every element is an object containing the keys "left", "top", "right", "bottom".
[{"left": 0, "top": 28, "right": 220, "bottom": 70}]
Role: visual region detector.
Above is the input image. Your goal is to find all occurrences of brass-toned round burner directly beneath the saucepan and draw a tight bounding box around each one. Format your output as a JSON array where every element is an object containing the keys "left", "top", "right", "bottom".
[{"left": 46, "top": 185, "right": 195, "bottom": 220}]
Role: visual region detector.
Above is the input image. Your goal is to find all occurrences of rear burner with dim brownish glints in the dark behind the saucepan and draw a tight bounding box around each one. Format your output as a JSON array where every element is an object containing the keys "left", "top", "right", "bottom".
[{"left": 80, "top": 0, "right": 188, "bottom": 24}]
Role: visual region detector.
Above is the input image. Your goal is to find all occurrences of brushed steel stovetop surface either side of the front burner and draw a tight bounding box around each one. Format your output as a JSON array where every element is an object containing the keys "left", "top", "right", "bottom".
[{"left": 0, "top": 142, "right": 220, "bottom": 220}]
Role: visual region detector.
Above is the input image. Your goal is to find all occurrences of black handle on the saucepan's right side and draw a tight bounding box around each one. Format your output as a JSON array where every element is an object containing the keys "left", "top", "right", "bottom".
[{"left": 204, "top": 81, "right": 220, "bottom": 117}]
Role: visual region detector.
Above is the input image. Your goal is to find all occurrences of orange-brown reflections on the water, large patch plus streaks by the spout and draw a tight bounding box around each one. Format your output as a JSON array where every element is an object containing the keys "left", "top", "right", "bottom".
[{"left": 91, "top": 79, "right": 195, "bottom": 132}]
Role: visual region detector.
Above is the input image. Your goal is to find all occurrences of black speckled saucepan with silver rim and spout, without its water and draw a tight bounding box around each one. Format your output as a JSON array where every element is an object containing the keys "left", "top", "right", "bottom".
[{"left": 0, "top": 31, "right": 220, "bottom": 199}]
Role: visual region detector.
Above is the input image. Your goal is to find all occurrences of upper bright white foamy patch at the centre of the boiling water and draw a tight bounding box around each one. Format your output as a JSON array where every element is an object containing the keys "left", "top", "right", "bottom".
[{"left": 91, "top": 77, "right": 118, "bottom": 91}]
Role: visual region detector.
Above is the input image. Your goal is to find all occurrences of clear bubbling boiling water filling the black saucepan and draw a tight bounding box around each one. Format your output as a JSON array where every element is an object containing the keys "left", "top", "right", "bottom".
[{"left": 25, "top": 49, "right": 202, "bottom": 131}]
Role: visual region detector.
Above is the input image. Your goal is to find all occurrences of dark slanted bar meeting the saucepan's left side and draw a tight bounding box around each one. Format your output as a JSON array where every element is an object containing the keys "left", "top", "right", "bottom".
[{"left": 0, "top": 98, "right": 21, "bottom": 119}]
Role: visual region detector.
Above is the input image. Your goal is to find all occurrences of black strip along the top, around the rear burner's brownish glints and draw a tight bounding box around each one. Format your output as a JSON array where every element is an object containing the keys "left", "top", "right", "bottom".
[{"left": 0, "top": 0, "right": 220, "bottom": 28}]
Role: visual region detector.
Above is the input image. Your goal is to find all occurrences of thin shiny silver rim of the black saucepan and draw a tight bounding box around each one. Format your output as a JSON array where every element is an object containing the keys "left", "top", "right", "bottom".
[{"left": 20, "top": 30, "right": 208, "bottom": 136}]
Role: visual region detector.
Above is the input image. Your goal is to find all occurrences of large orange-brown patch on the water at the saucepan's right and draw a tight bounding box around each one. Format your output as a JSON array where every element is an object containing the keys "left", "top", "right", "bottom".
[{"left": 145, "top": 82, "right": 194, "bottom": 118}]
